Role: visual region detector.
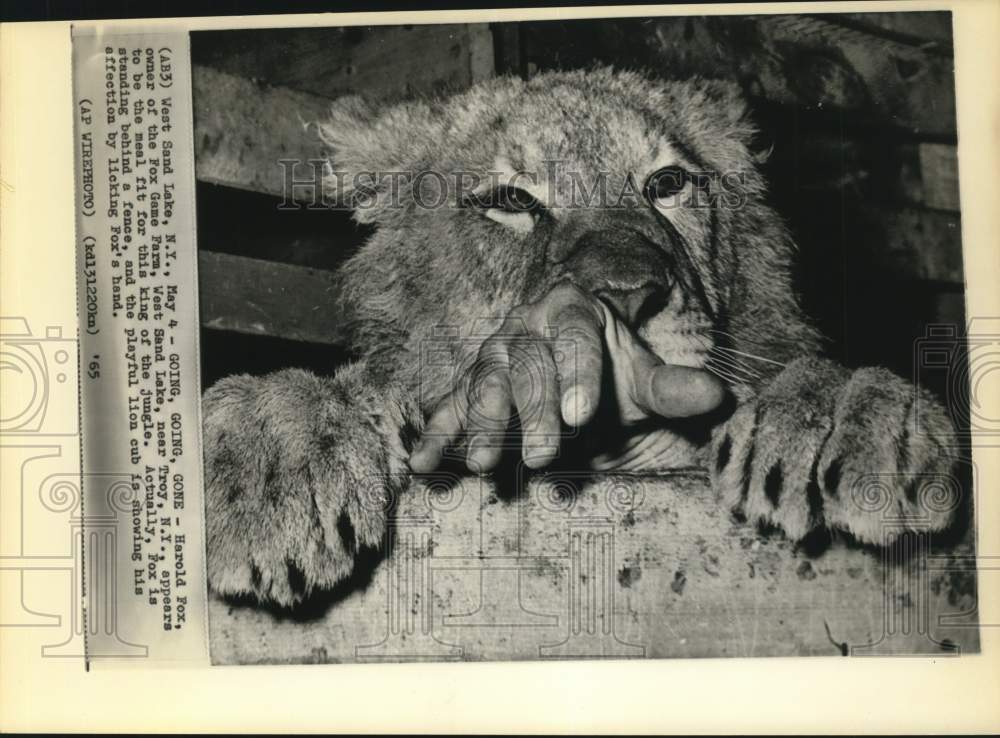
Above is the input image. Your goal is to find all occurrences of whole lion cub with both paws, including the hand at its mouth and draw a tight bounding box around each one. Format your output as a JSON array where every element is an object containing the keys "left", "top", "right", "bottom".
[{"left": 204, "top": 70, "right": 955, "bottom": 606}]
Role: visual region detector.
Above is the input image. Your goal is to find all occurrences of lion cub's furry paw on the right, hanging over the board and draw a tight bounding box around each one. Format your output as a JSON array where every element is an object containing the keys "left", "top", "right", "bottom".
[{"left": 710, "top": 359, "right": 960, "bottom": 543}]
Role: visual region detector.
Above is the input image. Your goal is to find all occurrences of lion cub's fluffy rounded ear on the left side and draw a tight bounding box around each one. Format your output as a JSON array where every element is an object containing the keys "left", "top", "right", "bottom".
[{"left": 317, "top": 95, "right": 442, "bottom": 223}]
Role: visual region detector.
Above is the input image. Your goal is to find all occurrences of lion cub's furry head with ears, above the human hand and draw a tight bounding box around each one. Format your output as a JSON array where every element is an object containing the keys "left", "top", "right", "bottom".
[{"left": 322, "top": 70, "right": 759, "bottom": 376}]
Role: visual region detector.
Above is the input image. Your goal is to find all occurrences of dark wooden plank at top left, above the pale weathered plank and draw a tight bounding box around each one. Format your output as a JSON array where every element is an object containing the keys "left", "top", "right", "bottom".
[{"left": 192, "top": 23, "right": 493, "bottom": 98}]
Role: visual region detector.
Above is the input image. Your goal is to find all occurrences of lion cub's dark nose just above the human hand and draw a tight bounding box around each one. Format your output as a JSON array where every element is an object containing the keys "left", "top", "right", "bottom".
[{"left": 561, "top": 229, "right": 674, "bottom": 327}]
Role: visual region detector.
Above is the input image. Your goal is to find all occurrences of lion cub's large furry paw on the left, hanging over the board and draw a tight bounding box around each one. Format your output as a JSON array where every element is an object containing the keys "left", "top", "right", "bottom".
[{"left": 203, "top": 370, "right": 406, "bottom": 607}]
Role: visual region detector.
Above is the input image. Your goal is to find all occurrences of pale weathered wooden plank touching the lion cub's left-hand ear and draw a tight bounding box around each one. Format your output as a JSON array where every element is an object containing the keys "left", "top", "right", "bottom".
[{"left": 192, "top": 66, "right": 330, "bottom": 202}]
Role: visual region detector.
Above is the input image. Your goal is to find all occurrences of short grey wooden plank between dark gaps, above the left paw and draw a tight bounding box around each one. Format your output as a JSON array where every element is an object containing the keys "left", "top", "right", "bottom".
[{"left": 198, "top": 249, "right": 343, "bottom": 344}]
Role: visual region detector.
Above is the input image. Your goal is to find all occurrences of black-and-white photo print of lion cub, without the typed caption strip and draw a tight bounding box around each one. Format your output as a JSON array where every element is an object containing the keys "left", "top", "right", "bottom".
[{"left": 191, "top": 12, "right": 979, "bottom": 664}]
